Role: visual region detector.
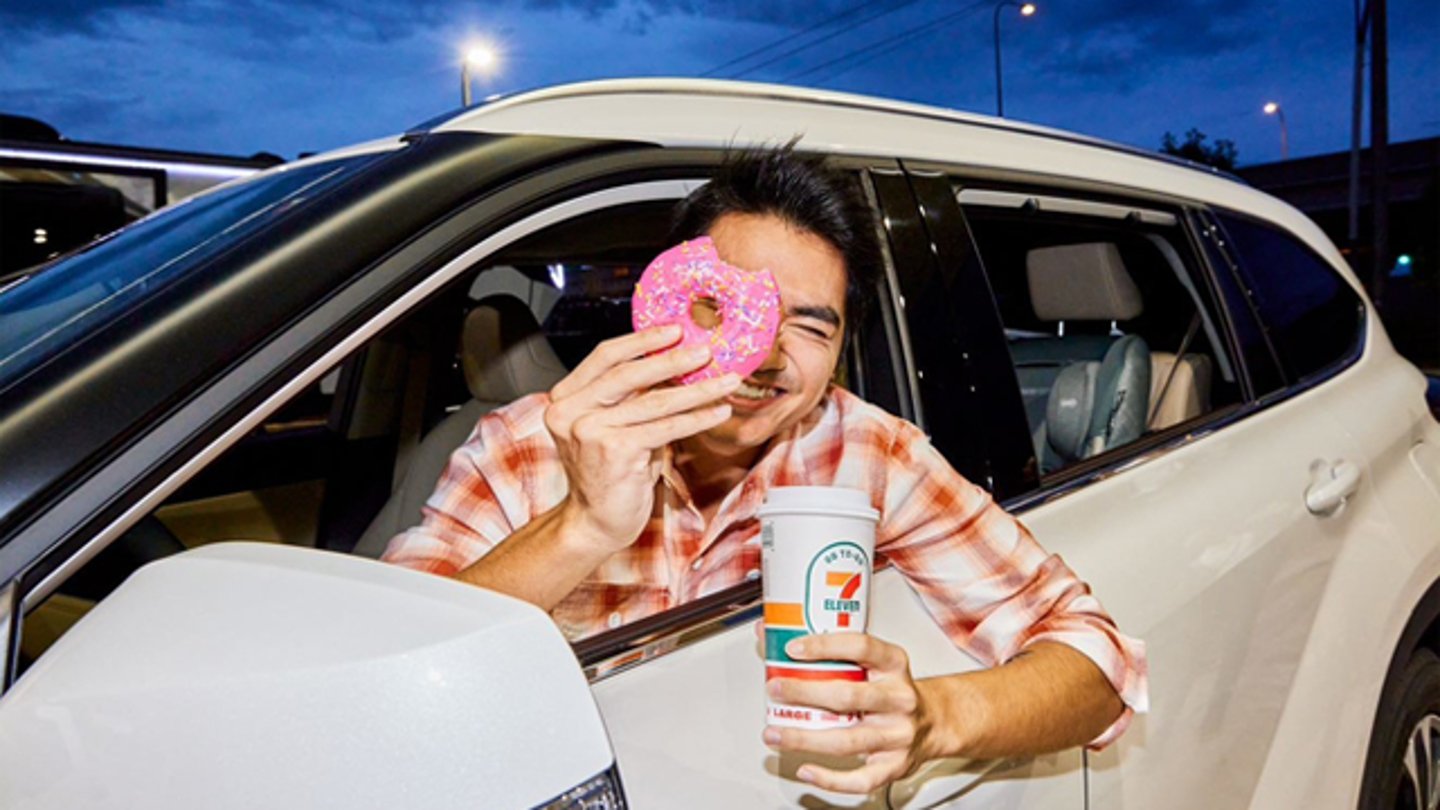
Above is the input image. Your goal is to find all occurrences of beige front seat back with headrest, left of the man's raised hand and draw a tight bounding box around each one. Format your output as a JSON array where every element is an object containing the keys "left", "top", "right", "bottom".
[{"left": 354, "top": 295, "right": 566, "bottom": 558}]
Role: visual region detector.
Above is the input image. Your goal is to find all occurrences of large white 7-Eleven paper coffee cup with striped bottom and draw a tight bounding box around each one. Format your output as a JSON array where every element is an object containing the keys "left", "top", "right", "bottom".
[{"left": 759, "top": 487, "right": 880, "bottom": 728}]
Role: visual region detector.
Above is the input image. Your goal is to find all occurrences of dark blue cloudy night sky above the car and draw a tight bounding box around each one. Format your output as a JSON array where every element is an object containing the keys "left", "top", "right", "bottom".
[{"left": 0, "top": 0, "right": 1440, "bottom": 164}]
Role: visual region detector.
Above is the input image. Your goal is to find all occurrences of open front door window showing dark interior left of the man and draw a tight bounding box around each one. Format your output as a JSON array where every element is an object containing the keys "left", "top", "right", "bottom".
[{"left": 19, "top": 179, "right": 887, "bottom": 670}]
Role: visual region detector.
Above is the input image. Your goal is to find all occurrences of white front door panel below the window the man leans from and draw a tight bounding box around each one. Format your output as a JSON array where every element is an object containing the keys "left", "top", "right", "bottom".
[{"left": 593, "top": 569, "right": 1084, "bottom": 810}]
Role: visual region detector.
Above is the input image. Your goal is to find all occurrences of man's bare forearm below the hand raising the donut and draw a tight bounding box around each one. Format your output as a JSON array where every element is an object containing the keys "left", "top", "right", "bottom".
[{"left": 455, "top": 502, "right": 609, "bottom": 611}]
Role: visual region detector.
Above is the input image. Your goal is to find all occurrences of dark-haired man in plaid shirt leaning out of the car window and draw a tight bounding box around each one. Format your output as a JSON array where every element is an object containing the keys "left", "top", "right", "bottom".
[{"left": 386, "top": 148, "right": 1146, "bottom": 793}]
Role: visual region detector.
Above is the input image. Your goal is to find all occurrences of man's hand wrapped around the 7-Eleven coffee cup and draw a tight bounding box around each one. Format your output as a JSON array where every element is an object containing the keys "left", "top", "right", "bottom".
[{"left": 765, "top": 633, "right": 945, "bottom": 793}]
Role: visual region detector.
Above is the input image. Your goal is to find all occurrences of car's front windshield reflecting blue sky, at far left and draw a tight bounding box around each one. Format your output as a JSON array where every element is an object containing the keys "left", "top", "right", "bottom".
[{"left": 0, "top": 156, "right": 372, "bottom": 389}]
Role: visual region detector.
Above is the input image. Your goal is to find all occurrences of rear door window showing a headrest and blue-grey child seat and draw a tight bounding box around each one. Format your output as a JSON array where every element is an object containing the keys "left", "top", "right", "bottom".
[{"left": 956, "top": 186, "right": 1241, "bottom": 477}]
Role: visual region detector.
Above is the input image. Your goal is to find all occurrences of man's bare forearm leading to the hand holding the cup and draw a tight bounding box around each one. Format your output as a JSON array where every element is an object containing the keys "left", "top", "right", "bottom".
[{"left": 916, "top": 641, "right": 1125, "bottom": 760}]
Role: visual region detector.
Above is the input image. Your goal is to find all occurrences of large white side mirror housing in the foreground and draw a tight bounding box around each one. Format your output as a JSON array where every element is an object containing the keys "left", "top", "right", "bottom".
[{"left": 0, "top": 543, "right": 622, "bottom": 810}]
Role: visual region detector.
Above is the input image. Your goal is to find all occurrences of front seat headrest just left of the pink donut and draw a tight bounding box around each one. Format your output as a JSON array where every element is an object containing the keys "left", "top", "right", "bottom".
[{"left": 461, "top": 295, "right": 567, "bottom": 402}]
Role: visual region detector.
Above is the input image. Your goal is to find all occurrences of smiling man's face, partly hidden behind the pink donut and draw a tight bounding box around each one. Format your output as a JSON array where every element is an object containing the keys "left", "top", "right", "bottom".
[{"left": 696, "top": 213, "right": 845, "bottom": 454}]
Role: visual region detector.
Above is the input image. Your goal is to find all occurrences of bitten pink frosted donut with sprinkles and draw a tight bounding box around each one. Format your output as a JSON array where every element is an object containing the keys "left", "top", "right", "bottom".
[{"left": 631, "top": 236, "right": 780, "bottom": 385}]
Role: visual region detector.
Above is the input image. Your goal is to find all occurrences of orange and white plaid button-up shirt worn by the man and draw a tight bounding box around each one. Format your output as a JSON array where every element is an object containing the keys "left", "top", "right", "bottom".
[{"left": 383, "top": 386, "right": 1148, "bottom": 747}]
